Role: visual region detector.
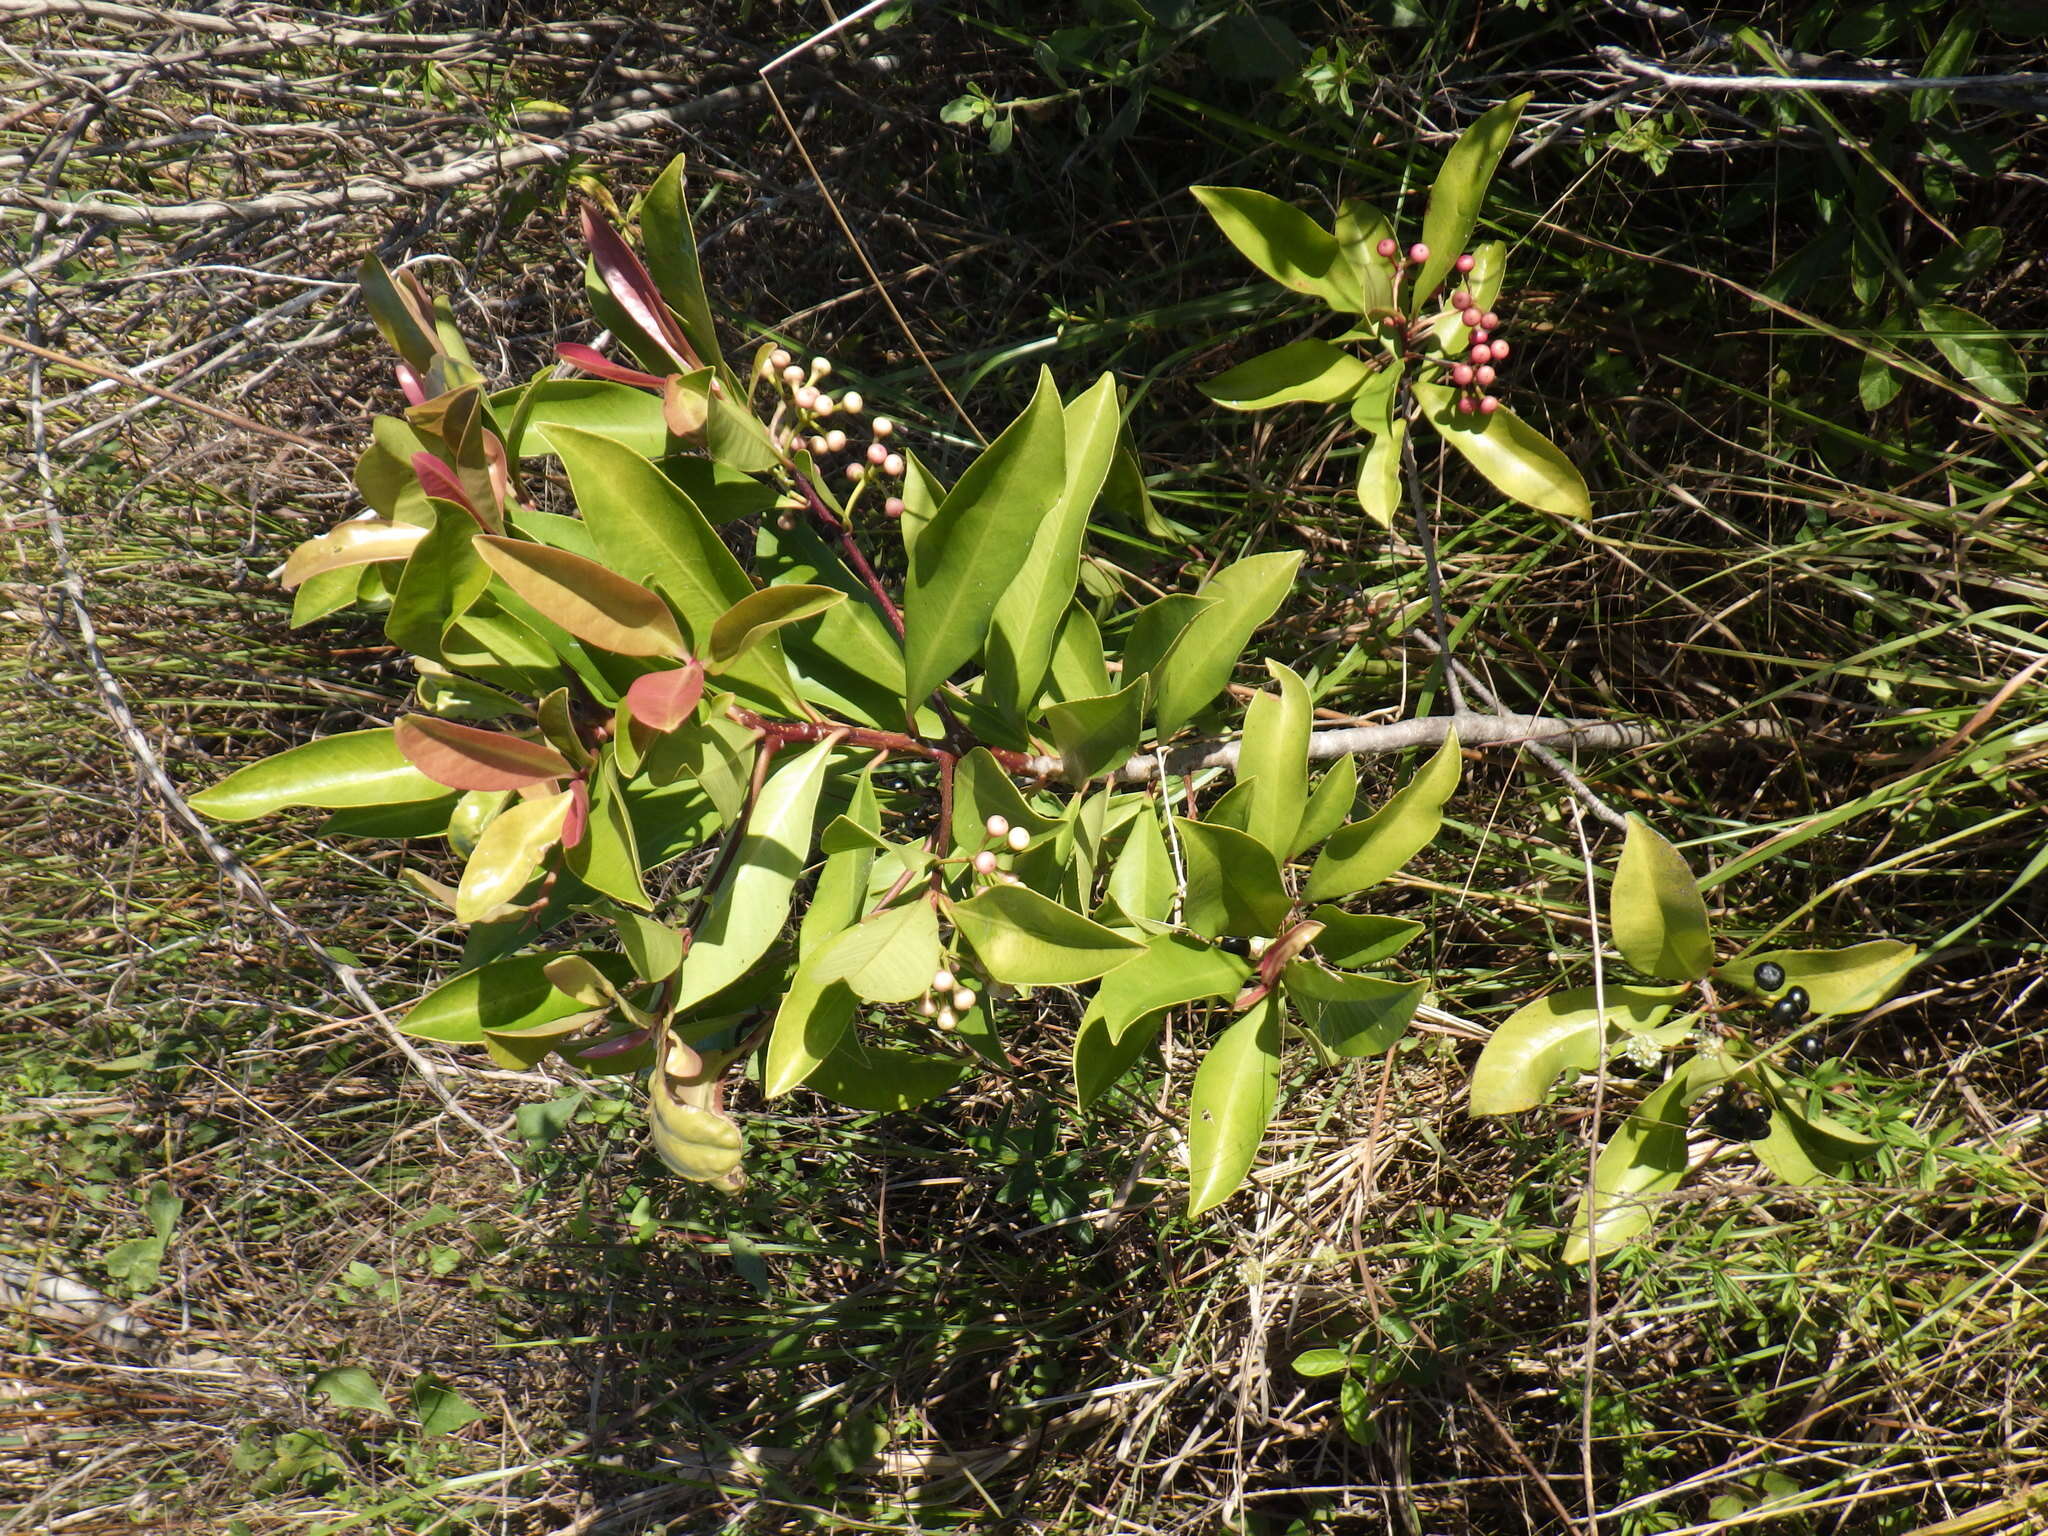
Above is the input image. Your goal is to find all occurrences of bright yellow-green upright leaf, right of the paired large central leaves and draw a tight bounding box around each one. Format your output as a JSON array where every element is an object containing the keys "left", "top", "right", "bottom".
[{"left": 983, "top": 373, "right": 1122, "bottom": 721}]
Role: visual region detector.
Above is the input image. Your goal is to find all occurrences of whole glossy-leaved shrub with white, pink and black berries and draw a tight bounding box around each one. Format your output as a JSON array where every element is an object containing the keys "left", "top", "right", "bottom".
[{"left": 193, "top": 111, "right": 1913, "bottom": 1257}]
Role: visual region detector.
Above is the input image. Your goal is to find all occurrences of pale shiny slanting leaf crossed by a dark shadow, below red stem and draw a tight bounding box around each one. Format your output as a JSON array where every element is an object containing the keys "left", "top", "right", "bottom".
[{"left": 674, "top": 741, "right": 834, "bottom": 1012}]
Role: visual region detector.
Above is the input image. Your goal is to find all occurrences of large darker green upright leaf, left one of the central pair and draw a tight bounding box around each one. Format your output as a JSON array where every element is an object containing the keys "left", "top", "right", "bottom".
[{"left": 903, "top": 373, "right": 1067, "bottom": 705}]
